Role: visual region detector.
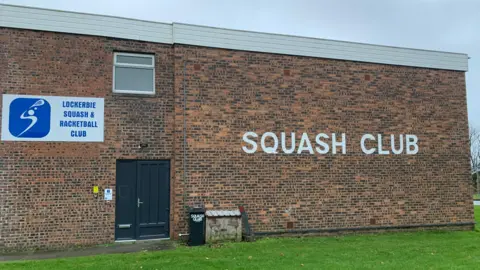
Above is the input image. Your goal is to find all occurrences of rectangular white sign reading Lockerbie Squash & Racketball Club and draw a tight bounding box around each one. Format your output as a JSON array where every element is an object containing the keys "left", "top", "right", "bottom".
[{"left": 2, "top": 94, "right": 104, "bottom": 142}]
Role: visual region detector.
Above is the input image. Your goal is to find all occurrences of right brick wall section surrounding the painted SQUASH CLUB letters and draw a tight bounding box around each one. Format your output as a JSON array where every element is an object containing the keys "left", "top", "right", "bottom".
[{"left": 175, "top": 45, "right": 473, "bottom": 232}]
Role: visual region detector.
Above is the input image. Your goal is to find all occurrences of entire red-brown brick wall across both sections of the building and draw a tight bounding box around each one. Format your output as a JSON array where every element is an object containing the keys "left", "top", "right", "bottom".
[{"left": 0, "top": 29, "right": 473, "bottom": 250}]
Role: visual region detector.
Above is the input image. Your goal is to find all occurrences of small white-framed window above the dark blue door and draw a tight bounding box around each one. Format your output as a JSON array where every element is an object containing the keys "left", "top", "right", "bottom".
[{"left": 113, "top": 53, "right": 155, "bottom": 94}]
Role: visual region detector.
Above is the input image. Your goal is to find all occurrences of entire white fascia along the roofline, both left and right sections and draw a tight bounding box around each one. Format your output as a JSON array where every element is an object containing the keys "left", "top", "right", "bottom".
[{"left": 0, "top": 4, "right": 468, "bottom": 71}]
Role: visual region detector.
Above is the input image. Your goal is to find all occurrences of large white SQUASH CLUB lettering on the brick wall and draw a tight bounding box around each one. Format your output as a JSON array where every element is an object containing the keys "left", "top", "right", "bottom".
[{"left": 242, "top": 132, "right": 418, "bottom": 155}]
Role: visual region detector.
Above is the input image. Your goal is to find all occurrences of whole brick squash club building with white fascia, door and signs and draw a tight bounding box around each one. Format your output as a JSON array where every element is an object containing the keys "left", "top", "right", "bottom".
[{"left": 0, "top": 5, "right": 474, "bottom": 250}]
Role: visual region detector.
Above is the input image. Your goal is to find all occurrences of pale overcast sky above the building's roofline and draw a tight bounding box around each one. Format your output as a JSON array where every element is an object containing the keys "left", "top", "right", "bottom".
[{"left": 0, "top": 0, "right": 480, "bottom": 128}]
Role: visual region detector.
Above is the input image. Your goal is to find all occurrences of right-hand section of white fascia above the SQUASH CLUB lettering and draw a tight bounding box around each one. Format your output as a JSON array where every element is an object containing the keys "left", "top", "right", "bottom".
[{"left": 173, "top": 23, "right": 468, "bottom": 71}]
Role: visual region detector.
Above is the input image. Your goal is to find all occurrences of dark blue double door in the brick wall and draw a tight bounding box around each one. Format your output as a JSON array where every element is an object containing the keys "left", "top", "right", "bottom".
[{"left": 115, "top": 160, "right": 170, "bottom": 240}]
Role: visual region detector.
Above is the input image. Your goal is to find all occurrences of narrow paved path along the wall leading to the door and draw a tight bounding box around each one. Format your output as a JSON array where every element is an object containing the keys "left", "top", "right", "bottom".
[{"left": 0, "top": 240, "right": 175, "bottom": 261}]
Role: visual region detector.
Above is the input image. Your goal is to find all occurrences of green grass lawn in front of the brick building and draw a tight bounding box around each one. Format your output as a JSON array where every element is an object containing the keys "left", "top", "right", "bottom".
[{"left": 0, "top": 207, "right": 480, "bottom": 270}]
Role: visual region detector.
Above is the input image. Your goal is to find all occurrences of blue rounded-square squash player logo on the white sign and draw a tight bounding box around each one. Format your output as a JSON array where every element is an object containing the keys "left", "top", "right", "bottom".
[{"left": 8, "top": 98, "right": 51, "bottom": 138}]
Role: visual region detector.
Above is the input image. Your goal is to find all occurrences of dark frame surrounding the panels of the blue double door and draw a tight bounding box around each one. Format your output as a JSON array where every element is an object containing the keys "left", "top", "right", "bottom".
[{"left": 113, "top": 159, "right": 172, "bottom": 242}]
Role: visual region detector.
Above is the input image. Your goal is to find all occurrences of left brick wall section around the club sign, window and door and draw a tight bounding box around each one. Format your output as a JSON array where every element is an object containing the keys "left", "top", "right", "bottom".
[{"left": 0, "top": 29, "right": 174, "bottom": 249}]
